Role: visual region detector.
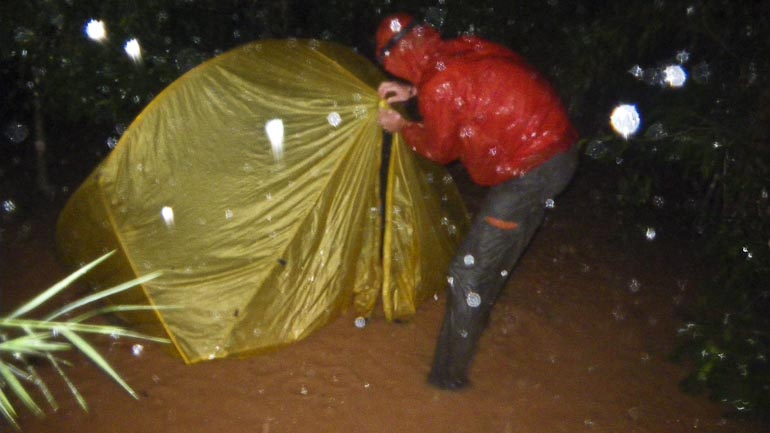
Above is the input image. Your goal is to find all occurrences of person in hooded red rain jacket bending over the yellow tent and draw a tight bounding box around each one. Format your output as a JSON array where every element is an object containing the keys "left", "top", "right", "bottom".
[{"left": 377, "top": 14, "right": 578, "bottom": 389}]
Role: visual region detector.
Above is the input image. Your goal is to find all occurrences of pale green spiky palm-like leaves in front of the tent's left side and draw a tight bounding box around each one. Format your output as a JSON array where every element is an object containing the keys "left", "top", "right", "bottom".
[{"left": 0, "top": 253, "right": 169, "bottom": 429}]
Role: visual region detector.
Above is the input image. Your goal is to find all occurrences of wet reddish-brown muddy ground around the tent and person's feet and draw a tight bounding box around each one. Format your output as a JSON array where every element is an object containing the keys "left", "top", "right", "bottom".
[{"left": 0, "top": 170, "right": 763, "bottom": 433}]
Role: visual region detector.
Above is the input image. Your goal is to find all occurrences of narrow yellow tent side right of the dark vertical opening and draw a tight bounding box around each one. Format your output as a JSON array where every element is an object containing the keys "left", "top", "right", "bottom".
[{"left": 382, "top": 135, "right": 470, "bottom": 320}]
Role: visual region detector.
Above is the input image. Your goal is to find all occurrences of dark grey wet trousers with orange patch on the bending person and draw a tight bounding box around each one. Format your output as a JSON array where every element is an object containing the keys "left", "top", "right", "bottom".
[{"left": 428, "top": 146, "right": 577, "bottom": 389}]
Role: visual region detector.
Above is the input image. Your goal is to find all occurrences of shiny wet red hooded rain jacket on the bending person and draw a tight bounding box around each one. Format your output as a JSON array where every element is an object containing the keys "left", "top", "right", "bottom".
[{"left": 383, "top": 25, "right": 578, "bottom": 186}]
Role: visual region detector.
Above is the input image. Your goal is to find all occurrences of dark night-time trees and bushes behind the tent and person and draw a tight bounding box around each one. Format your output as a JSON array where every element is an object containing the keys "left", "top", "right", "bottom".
[{"left": 0, "top": 0, "right": 770, "bottom": 419}]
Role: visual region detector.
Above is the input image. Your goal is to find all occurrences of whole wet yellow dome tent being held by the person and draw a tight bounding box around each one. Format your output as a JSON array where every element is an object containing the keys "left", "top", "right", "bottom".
[{"left": 57, "top": 40, "right": 468, "bottom": 363}]
